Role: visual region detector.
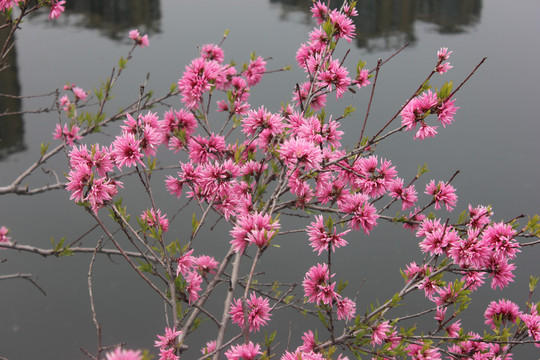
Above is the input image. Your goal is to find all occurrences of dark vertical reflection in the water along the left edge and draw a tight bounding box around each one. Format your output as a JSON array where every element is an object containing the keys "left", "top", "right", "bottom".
[{"left": 0, "top": 18, "right": 26, "bottom": 160}]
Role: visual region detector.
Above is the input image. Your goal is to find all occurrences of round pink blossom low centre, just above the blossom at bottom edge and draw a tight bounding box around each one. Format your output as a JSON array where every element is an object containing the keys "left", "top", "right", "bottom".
[{"left": 230, "top": 293, "right": 272, "bottom": 332}]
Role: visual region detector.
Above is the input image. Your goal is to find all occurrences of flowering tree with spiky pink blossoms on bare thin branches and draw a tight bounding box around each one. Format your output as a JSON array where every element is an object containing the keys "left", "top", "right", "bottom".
[{"left": 0, "top": 0, "right": 540, "bottom": 360}]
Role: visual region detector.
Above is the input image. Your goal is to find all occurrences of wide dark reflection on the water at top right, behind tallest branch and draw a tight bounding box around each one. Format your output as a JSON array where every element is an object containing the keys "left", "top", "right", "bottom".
[{"left": 270, "top": 0, "right": 482, "bottom": 52}]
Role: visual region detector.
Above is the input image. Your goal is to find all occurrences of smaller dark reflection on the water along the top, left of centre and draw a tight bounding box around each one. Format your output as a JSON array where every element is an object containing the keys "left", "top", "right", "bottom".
[{"left": 66, "top": 0, "right": 161, "bottom": 40}]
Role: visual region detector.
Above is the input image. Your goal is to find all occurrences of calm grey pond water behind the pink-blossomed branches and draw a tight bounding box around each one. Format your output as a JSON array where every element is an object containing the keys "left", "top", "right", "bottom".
[{"left": 0, "top": 0, "right": 540, "bottom": 360}]
